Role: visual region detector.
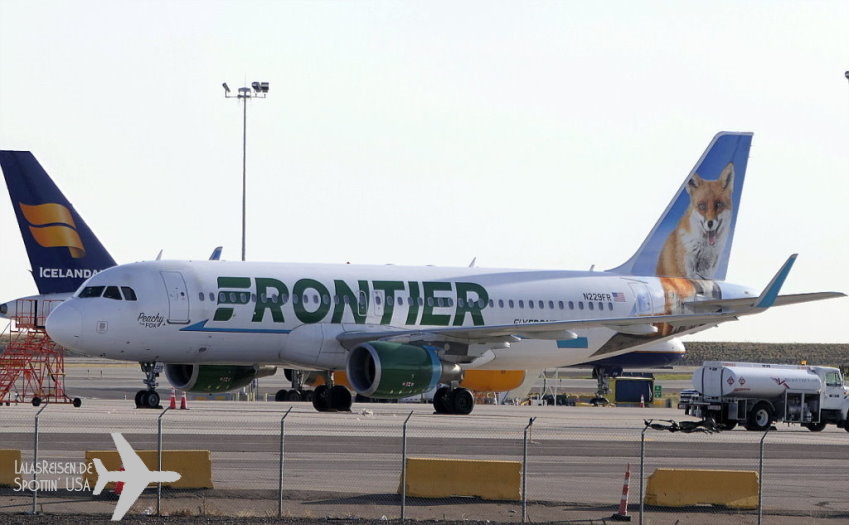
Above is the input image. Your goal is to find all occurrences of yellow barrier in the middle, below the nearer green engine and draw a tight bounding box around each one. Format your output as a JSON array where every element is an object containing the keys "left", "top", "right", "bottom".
[{"left": 398, "top": 458, "right": 522, "bottom": 501}]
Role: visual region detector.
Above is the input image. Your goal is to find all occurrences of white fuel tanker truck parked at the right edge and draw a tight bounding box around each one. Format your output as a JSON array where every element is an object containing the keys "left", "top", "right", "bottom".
[{"left": 678, "top": 361, "right": 849, "bottom": 432}]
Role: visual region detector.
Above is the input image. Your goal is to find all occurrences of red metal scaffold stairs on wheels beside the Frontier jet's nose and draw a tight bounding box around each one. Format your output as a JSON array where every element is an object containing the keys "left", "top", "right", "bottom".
[{"left": 0, "top": 299, "right": 81, "bottom": 407}]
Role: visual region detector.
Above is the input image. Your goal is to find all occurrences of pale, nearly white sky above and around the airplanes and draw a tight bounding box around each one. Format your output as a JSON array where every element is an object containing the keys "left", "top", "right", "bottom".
[{"left": 0, "top": 0, "right": 849, "bottom": 343}]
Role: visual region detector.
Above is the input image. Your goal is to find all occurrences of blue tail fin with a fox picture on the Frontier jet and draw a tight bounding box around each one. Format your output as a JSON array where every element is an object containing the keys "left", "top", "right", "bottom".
[{"left": 609, "top": 132, "right": 752, "bottom": 280}]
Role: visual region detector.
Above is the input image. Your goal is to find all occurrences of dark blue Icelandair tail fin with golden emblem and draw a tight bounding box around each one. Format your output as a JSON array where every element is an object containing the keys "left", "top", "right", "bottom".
[{"left": 0, "top": 151, "right": 115, "bottom": 294}]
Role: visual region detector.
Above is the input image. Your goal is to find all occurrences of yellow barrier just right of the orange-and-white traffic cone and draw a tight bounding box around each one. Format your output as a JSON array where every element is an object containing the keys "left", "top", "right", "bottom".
[{"left": 645, "top": 468, "right": 758, "bottom": 509}]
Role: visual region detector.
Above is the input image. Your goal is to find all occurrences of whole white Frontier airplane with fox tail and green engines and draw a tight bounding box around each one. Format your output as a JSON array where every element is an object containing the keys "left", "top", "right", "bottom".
[{"left": 38, "top": 132, "right": 844, "bottom": 414}]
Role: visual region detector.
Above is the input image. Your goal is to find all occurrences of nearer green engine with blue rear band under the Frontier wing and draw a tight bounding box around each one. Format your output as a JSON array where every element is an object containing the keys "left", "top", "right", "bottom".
[{"left": 345, "top": 341, "right": 460, "bottom": 399}]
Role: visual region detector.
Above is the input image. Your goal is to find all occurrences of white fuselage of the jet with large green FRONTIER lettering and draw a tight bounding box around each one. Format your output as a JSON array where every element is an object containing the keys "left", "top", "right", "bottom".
[{"left": 48, "top": 261, "right": 757, "bottom": 370}]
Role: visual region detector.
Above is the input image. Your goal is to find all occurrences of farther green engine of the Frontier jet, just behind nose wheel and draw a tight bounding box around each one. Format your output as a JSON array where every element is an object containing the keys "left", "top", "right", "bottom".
[{"left": 165, "top": 364, "right": 277, "bottom": 392}]
